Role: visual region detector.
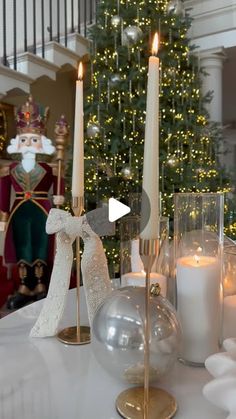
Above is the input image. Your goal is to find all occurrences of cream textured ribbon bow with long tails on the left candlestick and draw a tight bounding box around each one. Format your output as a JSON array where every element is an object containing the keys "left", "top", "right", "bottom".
[{"left": 30, "top": 209, "right": 111, "bottom": 337}]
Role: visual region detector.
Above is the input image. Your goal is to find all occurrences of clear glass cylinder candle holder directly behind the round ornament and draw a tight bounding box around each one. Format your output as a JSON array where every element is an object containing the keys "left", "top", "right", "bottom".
[{"left": 120, "top": 216, "right": 169, "bottom": 297}]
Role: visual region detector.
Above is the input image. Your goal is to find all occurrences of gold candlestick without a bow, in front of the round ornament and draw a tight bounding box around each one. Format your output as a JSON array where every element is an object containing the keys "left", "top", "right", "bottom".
[{"left": 116, "top": 239, "right": 177, "bottom": 419}]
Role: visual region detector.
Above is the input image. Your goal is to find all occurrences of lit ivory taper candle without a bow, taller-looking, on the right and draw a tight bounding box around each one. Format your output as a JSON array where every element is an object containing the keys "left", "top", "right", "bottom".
[{"left": 140, "top": 33, "right": 159, "bottom": 239}]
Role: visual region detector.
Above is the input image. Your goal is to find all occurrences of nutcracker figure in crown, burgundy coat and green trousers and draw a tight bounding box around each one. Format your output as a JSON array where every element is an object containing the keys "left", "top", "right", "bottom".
[{"left": 0, "top": 97, "right": 64, "bottom": 309}]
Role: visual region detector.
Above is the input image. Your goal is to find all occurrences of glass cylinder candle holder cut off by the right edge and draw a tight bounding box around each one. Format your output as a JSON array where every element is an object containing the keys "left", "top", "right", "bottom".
[{"left": 223, "top": 243, "right": 236, "bottom": 339}]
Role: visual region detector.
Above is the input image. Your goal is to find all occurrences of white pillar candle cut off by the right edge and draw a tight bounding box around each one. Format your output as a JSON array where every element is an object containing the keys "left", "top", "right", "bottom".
[{"left": 223, "top": 295, "right": 236, "bottom": 339}]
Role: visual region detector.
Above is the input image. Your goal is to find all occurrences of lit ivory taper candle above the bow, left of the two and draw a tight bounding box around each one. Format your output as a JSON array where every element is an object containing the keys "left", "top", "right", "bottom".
[{"left": 72, "top": 63, "right": 84, "bottom": 197}]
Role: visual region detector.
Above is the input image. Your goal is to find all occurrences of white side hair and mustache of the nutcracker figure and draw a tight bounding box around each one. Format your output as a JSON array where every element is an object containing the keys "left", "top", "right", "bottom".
[{"left": 7, "top": 135, "right": 55, "bottom": 157}]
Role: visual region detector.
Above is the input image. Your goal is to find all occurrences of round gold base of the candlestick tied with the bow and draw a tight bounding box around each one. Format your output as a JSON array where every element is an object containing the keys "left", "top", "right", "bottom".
[{"left": 57, "top": 326, "right": 91, "bottom": 345}]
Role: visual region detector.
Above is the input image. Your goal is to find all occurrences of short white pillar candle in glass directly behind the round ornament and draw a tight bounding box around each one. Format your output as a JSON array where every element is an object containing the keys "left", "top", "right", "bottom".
[{"left": 121, "top": 272, "right": 167, "bottom": 297}]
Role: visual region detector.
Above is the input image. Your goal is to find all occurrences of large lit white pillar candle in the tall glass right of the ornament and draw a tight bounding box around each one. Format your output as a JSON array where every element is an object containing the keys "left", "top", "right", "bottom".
[{"left": 176, "top": 256, "right": 222, "bottom": 363}]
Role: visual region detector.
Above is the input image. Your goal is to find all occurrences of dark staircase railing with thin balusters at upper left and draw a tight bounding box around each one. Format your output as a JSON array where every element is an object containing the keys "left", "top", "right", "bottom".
[{"left": 0, "top": 0, "right": 98, "bottom": 70}]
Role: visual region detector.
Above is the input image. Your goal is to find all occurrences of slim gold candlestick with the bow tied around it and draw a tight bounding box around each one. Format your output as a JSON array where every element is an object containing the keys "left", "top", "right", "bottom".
[{"left": 57, "top": 197, "right": 91, "bottom": 345}]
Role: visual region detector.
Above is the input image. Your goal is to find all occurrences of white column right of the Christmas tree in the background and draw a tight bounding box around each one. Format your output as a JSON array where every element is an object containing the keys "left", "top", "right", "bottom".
[{"left": 199, "top": 48, "right": 226, "bottom": 124}]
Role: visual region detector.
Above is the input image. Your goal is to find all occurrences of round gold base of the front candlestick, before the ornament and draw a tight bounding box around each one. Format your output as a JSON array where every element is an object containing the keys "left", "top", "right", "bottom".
[{"left": 116, "top": 387, "right": 177, "bottom": 419}]
